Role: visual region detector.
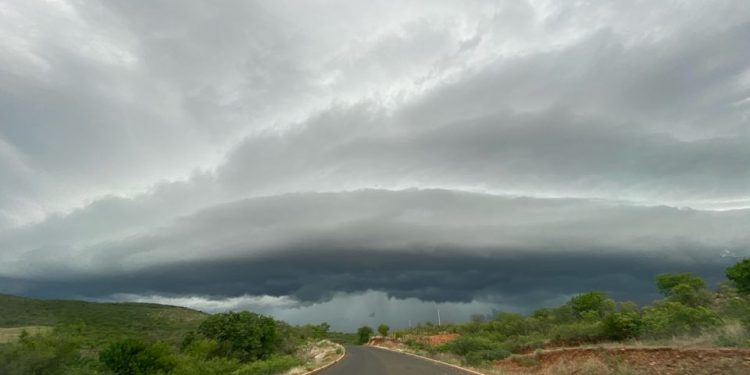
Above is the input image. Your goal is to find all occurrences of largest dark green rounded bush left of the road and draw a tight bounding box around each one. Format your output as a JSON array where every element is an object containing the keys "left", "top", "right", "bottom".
[{"left": 198, "top": 311, "right": 278, "bottom": 362}]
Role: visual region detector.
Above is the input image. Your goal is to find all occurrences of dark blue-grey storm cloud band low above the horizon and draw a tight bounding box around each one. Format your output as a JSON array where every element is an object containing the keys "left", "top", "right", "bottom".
[{"left": 0, "top": 249, "right": 731, "bottom": 310}]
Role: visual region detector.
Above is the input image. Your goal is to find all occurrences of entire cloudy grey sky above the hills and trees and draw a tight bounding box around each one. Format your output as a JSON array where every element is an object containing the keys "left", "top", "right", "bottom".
[{"left": 0, "top": 0, "right": 750, "bottom": 330}]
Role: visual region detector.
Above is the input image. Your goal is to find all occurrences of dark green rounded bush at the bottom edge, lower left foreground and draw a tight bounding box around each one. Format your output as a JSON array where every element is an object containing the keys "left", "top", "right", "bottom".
[{"left": 99, "top": 339, "right": 176, "bottom": 375}]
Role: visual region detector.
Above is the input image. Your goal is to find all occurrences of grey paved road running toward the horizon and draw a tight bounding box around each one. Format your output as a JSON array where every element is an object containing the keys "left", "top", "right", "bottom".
[{"left": 320, "top": 346, "right": 469, "bottom": 375}]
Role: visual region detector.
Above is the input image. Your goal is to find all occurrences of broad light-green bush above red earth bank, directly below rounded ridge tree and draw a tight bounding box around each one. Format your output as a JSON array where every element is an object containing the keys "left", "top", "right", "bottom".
[{"left": 643, "top": 301, "right": 721, "bottom": 337}]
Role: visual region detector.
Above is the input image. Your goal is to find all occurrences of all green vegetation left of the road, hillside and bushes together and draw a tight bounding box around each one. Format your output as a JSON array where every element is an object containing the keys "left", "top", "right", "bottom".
[{"left": 0, "top": 296, "right": 344, "bottom": 375}]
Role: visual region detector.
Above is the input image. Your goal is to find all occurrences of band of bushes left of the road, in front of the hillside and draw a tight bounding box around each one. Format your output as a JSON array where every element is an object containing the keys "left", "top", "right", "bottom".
[{"left": 0, "top": 312, "right": 340, "bottom": 375}]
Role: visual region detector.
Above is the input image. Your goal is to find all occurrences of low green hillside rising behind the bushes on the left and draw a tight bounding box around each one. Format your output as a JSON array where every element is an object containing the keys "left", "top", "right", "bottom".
[{"left": 0, "top": 295, "right": 208, "bottom": 344}]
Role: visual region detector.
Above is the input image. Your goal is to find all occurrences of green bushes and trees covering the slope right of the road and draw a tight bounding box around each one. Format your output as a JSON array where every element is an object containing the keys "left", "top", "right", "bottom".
[{"left": 395, "top": 259, "right": 750, "bottom": 365}]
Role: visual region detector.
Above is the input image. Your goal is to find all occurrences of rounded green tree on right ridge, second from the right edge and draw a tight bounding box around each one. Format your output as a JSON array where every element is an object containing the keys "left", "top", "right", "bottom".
[{"left": 656, "top": 272, "right": 711, "bottom": 307}]
